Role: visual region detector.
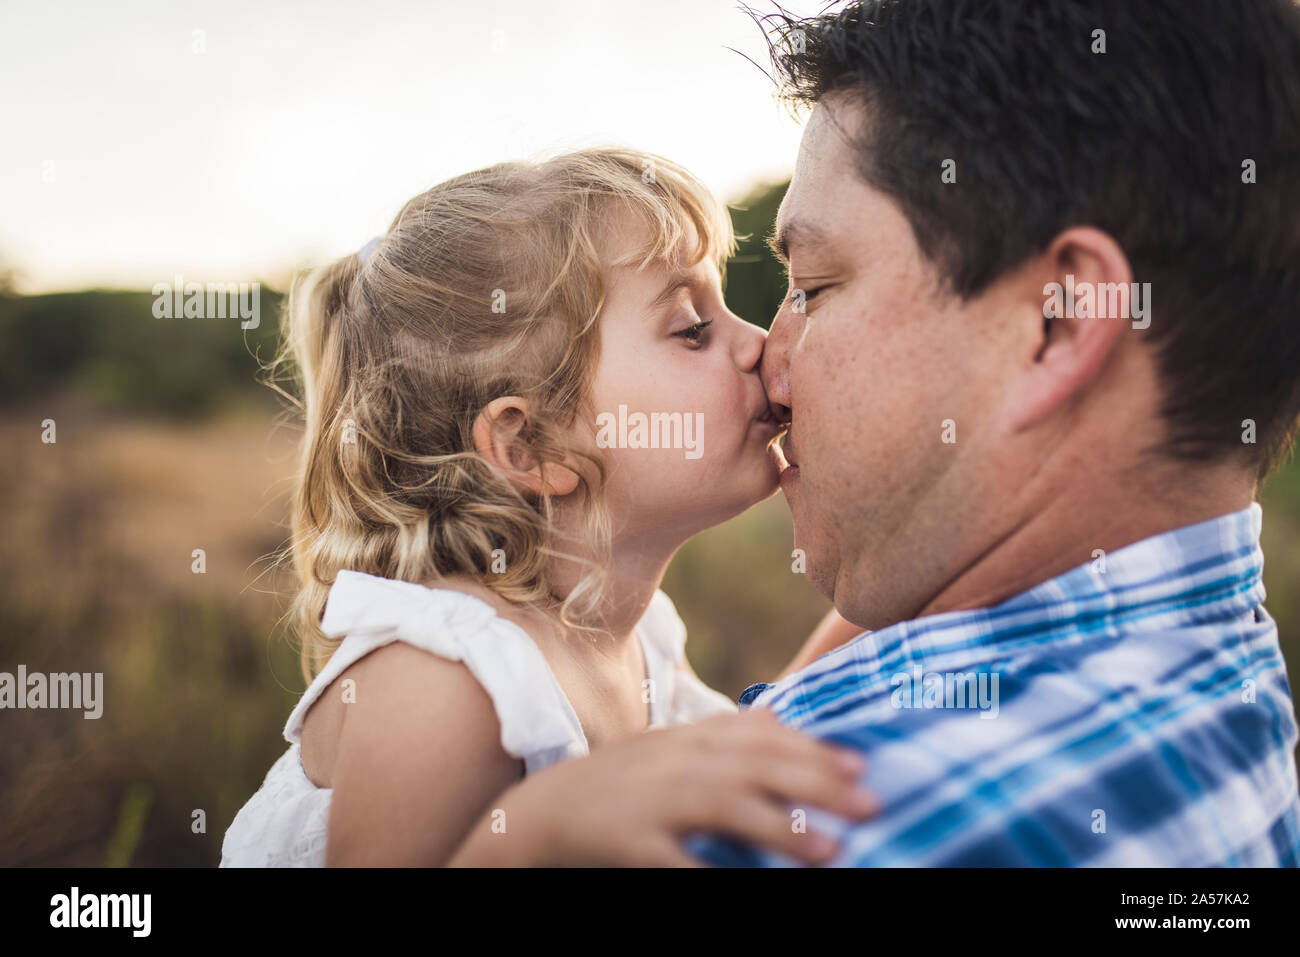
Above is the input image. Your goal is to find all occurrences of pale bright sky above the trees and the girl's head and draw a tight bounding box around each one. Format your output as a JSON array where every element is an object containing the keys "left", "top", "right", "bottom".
[{"left": 0, "top": 0, "right": 824, "bottom": 293}]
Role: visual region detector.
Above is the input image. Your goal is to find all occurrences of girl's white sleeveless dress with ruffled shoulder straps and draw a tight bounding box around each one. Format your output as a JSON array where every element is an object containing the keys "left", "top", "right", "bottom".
[{"left": 221, "top": 571, "right": 737, "bottom": 867}]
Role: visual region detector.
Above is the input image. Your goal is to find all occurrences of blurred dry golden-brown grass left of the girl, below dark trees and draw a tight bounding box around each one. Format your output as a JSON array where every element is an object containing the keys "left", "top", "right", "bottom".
[{"left": 0, "top": 404, "right": 302, "bottom": 865}]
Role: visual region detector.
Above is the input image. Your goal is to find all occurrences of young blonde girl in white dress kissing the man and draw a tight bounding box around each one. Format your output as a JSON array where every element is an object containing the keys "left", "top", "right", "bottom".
[{"left": 221, "top": 150, "right": 872, "bottom": 866}]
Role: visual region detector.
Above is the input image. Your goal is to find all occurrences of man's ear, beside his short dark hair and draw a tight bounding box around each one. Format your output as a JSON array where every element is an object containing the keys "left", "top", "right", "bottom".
[{"left": 1010, "top": 226, "right": 1132, "bottom": 432}]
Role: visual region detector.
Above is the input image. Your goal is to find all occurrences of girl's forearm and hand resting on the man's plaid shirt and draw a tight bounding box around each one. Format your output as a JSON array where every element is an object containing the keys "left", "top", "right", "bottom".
[{"left": 450, "top": 709, "right": 879, "bottom": 867}]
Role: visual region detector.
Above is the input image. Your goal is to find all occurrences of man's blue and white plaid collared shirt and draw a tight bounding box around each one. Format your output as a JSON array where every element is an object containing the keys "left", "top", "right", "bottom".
[{"left": 688, "top": 505, "right": 1300, "bottom": 867}]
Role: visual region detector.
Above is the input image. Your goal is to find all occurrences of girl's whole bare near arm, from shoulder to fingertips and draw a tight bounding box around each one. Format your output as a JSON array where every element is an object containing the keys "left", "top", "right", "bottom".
[{"left": 325, "top": 642, "right": 878, "bottom": 866}]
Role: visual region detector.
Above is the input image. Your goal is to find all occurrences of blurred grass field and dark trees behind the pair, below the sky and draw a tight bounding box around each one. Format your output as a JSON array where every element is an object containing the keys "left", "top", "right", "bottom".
[{"left": 0, "top": 189, "right": 1300, "bottom": 866}]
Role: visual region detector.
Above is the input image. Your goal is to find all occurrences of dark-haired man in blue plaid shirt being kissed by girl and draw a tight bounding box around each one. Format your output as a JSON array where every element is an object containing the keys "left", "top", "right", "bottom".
[{"left": 690, "top": 0, "right": 1300, "bottom": 866}]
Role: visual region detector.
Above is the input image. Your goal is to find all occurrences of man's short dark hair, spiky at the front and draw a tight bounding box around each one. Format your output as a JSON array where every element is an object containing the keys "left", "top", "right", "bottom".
[{"left": 757, "top": 0, "right": 1300, "bottom": 477}]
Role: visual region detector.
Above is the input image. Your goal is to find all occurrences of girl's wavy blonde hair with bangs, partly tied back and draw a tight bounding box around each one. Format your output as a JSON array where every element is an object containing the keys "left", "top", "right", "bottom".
[{"left": 272, "top": 150, "right": 735, "bottom": 681}]
